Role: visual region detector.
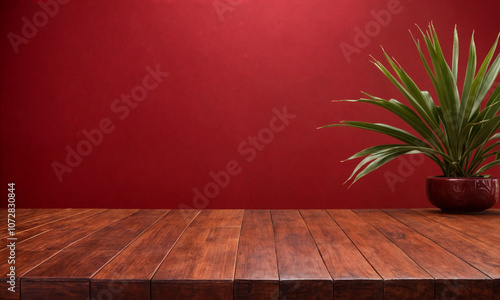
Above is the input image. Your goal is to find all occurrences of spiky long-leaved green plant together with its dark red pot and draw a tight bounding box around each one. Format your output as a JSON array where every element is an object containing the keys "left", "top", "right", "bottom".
[{"left": 320, "top": 23, "right": 500, "bottom": 213}]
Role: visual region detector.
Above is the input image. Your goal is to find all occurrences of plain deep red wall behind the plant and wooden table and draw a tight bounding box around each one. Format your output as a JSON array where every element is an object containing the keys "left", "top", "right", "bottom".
[{"left": 0, "top": 0, "right": 500, "bottom": 208}]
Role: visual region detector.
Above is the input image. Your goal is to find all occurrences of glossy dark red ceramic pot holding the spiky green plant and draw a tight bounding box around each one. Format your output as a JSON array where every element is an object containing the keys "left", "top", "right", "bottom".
[{"left": 426, "top": 176, "right": 499, "bottom": 213}]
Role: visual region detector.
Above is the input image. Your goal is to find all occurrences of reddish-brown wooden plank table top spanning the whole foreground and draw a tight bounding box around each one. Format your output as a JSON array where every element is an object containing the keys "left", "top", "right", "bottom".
[{"left": 0, "top": 209, "right": 500, "bottom": 300}]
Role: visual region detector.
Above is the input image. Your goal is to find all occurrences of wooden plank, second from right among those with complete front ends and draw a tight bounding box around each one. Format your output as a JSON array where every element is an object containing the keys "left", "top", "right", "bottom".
[{"left": 328, "top": 210, "right": 434, "bottom": 299}]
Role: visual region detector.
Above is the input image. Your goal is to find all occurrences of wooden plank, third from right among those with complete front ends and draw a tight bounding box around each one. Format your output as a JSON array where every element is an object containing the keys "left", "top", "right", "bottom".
[{"left": 300, "top": 210, "right": 384, "bottom": 299}]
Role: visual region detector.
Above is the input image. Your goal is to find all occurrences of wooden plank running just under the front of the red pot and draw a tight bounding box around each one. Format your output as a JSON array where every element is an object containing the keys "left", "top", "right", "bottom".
[{"left": 413, "top": 209, "right": 500, "bottom": 245}]
